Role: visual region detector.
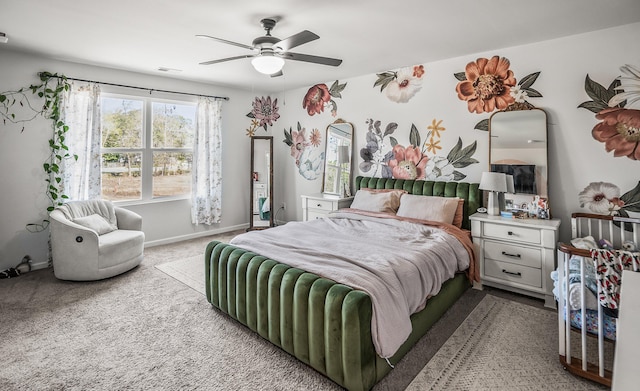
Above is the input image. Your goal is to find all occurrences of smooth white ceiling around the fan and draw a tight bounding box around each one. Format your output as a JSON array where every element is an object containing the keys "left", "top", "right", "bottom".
[{"left": 0, "top": 0, "right": 640, "bottom": 92}]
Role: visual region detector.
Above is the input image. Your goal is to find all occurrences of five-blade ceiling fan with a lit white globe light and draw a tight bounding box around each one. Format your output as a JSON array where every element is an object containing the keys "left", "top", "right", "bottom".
[{"left": 196, "top": 18, "right": 342, "bottom": 77}]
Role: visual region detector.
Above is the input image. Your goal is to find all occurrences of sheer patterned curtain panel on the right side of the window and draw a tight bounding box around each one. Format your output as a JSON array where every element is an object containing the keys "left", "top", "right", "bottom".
[{"left": 191, "top": 97, "right": 222, "bottom": 225}]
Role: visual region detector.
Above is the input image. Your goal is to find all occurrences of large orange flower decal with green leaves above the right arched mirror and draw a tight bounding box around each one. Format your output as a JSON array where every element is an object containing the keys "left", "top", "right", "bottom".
[{"left": 454, "top": 56, "right": 542, "bottom": 130}]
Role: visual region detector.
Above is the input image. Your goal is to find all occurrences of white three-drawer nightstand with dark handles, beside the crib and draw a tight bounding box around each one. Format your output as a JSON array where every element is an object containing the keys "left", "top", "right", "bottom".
[{"left": 469, "top": 213, "right": 560, "bottom": 308}]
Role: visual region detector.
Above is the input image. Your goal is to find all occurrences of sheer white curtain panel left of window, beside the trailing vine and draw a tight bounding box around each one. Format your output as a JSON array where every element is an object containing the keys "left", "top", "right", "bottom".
[{"left": 62, "top": 83, "right": 101, "bottom": 200}]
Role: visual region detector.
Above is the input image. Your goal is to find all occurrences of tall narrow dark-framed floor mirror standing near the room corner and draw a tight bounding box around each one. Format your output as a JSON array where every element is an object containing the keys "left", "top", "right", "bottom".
[{"left": 249, "top": 136, "right": 273, "bottom": 230}]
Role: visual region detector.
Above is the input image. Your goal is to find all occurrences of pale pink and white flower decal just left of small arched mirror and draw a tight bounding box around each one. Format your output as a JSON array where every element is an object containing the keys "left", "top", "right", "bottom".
[{"left": 282, "top": 122, "right": 324, "bottom": 181}]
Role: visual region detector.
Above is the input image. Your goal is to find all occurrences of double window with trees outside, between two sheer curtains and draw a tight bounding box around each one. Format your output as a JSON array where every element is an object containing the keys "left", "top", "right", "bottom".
[{"left": 100, "top": 95, "right": 196, "bottom": 201}]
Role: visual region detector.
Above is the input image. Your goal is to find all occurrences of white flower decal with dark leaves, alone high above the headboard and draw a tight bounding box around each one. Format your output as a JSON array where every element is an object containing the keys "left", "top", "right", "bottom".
[{"left": 373, "top": 65, "right": 425, "bottom": 103}]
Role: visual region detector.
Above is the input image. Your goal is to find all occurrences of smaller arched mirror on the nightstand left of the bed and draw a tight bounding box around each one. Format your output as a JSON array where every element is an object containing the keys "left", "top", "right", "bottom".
[{"left": 322, "top": 119, "right": 353, "bottom": 197}]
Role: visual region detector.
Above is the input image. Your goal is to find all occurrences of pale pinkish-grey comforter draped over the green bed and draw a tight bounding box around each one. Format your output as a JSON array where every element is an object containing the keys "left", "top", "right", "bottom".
[{"left": 230, "top": 212, "right": 471, "bottom": 358}]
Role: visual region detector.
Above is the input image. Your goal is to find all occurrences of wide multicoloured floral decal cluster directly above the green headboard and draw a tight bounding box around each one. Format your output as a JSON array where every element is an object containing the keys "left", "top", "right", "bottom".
[{"left": 360, "top": 119, "right": 478, "bottom": 181}]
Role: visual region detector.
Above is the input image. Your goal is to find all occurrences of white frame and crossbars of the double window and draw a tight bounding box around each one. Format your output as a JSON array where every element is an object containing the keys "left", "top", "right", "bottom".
[{"left": 100, "top": 91, "right": 197, "bottom": 206}]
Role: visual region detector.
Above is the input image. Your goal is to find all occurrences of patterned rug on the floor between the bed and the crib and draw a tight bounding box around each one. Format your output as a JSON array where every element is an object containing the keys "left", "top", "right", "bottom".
[{"left": 407, "top": 295, "right": 608, "bottom": 391}]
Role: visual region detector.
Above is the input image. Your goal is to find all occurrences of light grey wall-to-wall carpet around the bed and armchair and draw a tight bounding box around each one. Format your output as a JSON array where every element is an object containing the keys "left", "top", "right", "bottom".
[{"left": 0, "top": 231, "right": 604, "bottom": 390}]
